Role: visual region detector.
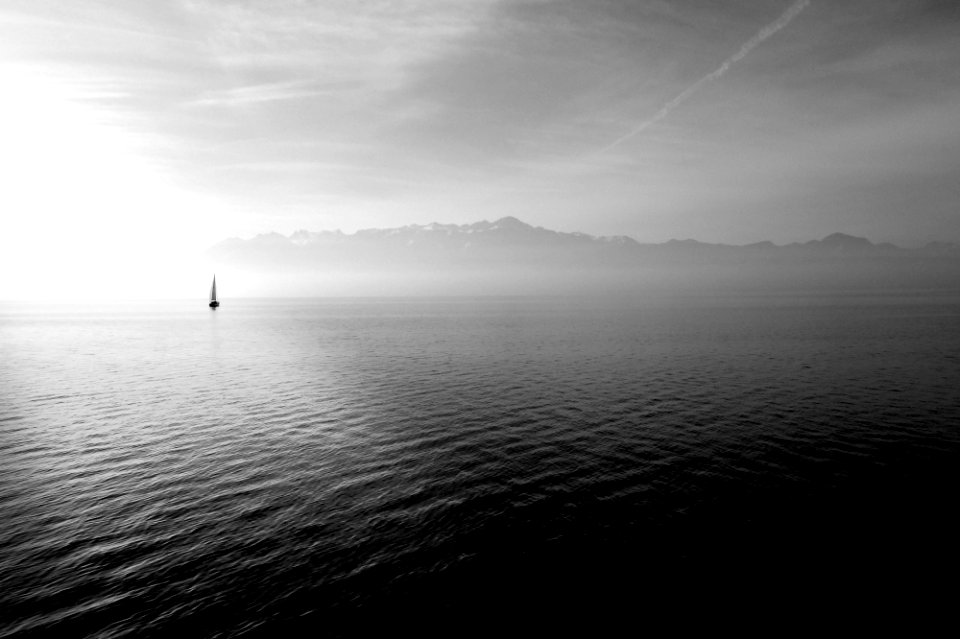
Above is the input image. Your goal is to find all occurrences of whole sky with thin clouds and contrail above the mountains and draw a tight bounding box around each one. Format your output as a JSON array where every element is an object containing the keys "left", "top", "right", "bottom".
[{"left": 0, "top": 0, "right": 960, "bottom": 298}]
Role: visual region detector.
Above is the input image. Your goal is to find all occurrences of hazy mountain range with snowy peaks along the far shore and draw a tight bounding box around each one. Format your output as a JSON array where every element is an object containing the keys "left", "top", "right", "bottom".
[{"left": 209, "top": 217, "right": 960, "bottom": 295}]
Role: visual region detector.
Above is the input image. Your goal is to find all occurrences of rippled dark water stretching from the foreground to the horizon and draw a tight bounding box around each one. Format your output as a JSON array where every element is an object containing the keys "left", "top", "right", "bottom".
[{"left": 0, "top": 295, "right": 960, "bottom": 637}]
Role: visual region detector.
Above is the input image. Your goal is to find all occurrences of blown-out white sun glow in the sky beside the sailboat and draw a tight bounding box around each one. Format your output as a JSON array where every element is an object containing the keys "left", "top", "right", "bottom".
[{"left": 0, "top": 66, "right": 222, "bottom": 300}]
